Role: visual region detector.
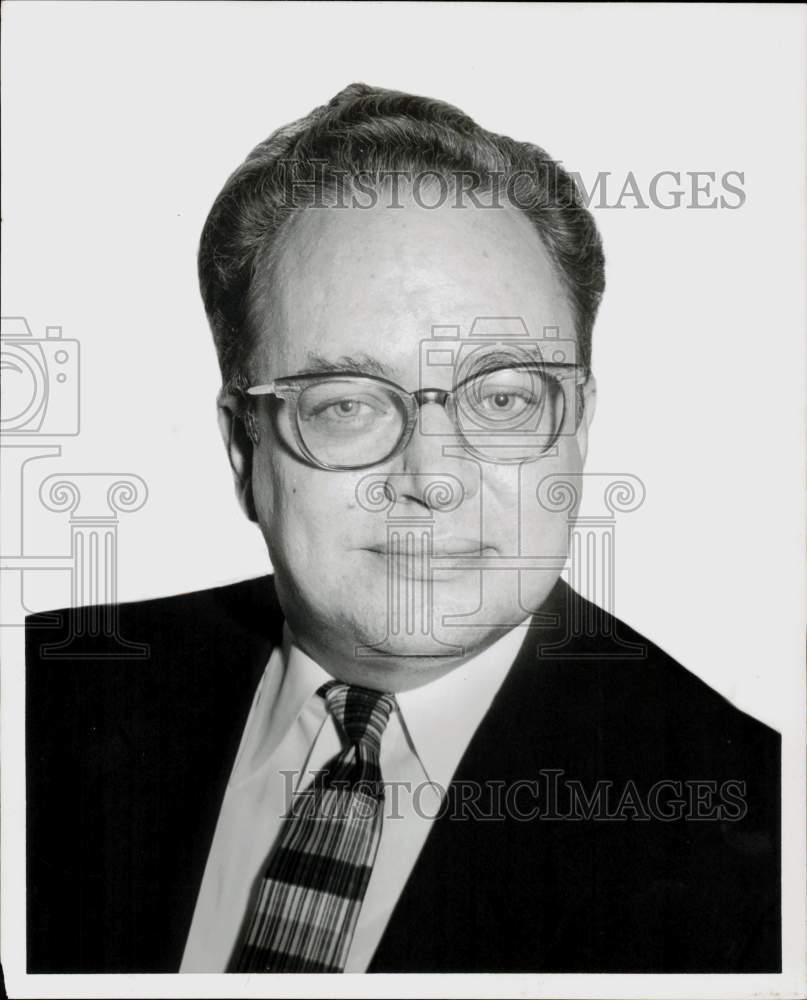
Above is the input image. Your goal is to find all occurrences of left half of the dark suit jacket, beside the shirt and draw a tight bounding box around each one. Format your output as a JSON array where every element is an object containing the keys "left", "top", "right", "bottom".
[{"left": 25, "top": 577, "right": 282, "bottom": 972}]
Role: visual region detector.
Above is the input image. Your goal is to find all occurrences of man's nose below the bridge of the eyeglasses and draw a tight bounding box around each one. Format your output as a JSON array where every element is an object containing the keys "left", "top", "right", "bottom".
[{"left": 386, "top": 402, "right": 481, "bottom": 510}]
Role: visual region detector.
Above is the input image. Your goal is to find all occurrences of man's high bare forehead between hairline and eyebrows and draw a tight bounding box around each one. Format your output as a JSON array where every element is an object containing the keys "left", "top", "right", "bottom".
[{"left": 252, "top": 199, "right": 574, "bottom": 379}]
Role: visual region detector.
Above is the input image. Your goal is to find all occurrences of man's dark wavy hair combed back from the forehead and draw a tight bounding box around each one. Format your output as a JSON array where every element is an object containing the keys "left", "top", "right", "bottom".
[{"left": 199, "top": 83, "right": 605, "bottom": 386}]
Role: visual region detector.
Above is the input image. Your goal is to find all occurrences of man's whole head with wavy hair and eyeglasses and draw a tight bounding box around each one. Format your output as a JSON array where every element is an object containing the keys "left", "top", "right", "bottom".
[{"left": 199, "top": 85, "right": 604, "bottom": 689}]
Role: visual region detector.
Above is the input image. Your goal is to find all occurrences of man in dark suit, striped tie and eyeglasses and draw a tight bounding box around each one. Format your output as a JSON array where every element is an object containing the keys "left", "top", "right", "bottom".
[{"left": 27, "top": 85, "right": 781, "bottom": 972}]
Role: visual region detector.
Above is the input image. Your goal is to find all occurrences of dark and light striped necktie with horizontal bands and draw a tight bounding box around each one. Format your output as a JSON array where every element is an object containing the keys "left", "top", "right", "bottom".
[{"left": 231, "top": 681, "right": 395, "bottom": 972}]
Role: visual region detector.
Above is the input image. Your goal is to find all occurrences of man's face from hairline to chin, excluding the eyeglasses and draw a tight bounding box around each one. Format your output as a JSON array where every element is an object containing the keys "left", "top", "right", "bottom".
[{"left": 224, "top": 189, "right": 593, "bottom": 690}]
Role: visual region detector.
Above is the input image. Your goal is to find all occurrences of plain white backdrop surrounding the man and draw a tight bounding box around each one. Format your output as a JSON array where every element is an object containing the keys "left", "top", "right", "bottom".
[{"left": 3, "top": 0, "right": 805, "bottom": 996}]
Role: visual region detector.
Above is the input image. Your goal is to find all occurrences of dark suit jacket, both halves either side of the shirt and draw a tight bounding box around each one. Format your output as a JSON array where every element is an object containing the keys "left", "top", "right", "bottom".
[{"left": 26, "top": 577, "right": 781, "bottom": 972}]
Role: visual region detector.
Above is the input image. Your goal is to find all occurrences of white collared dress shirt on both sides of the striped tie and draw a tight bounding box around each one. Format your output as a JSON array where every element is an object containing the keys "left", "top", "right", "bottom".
[{"left": 180, "top": 622, "right": 526, "bottom": 972}]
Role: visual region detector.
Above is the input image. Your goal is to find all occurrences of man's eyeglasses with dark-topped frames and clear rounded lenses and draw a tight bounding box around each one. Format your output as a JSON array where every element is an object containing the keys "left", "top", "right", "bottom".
[{"left": 246, "top": 363, "right": 588, "bottom": 470}]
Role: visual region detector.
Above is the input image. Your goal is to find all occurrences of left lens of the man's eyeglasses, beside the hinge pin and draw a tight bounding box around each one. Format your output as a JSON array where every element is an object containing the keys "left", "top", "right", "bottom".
[{"left": 297, "top": 378, "right": 406, "bottom": 469}]
